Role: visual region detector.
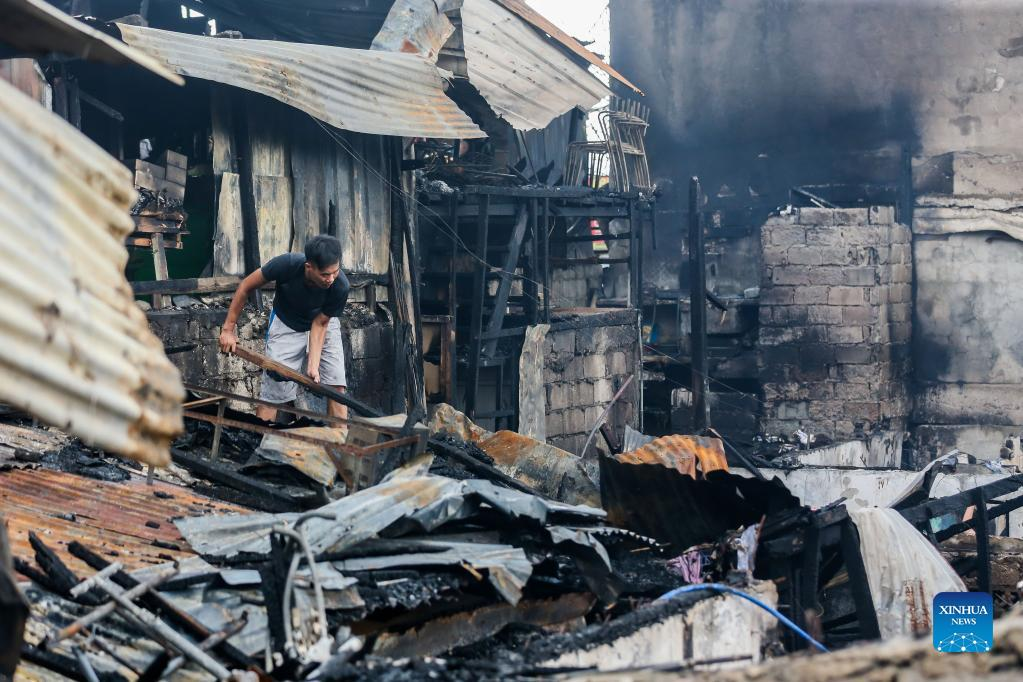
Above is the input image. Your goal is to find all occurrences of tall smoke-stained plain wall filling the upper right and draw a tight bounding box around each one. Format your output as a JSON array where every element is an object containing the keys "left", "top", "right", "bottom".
[{"left": 611, "top": 0, "right": 1023, "bottom": 288}]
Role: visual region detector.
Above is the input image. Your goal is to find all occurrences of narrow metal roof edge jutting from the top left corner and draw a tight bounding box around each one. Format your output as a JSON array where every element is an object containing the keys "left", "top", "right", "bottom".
[{"left": 0, "top": 0, "right": 184, "bottom": 85}]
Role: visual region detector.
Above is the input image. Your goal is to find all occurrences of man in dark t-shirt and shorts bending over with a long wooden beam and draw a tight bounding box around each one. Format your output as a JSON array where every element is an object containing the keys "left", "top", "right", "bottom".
[{"left": 220, "top": 235, "right": 350, "bottom": 421}]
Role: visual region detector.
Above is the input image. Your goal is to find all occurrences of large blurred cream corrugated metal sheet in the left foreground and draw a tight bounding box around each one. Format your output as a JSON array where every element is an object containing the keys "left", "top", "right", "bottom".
[{"left": 0, "top": 81, "right": 184, "bottom": 465}]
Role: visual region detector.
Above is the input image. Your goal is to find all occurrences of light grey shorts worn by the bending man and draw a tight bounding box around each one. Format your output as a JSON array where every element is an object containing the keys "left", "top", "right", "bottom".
[{"left": 260, "top": 315, "right": 348, "bottom": 403}]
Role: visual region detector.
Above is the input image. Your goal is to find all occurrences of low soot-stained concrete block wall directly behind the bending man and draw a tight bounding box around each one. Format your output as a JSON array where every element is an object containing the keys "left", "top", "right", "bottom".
[{"left": 147, "top": 307, "right": 394, "bottom": 410}]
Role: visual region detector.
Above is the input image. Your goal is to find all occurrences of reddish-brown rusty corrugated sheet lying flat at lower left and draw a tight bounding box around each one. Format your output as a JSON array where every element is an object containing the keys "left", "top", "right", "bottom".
[{"left": 0, "top": 469, "right": 244, "bottom": 575}]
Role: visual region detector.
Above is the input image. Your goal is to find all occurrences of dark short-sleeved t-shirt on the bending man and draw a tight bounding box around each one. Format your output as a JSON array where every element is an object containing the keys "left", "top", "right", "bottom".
[{"left": 261, "top": 254, "right": 351, "bottom": 331}]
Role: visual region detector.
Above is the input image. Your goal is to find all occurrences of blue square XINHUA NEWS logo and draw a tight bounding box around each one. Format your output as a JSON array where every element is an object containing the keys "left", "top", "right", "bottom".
[{"left": 932, "top": 592, "right": 994, "bottom": 653}]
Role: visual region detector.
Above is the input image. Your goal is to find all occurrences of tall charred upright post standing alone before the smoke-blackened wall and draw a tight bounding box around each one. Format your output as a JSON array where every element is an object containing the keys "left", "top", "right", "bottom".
[{"left": 690, "top": 177, "right": 710, "bottom": 434}]
